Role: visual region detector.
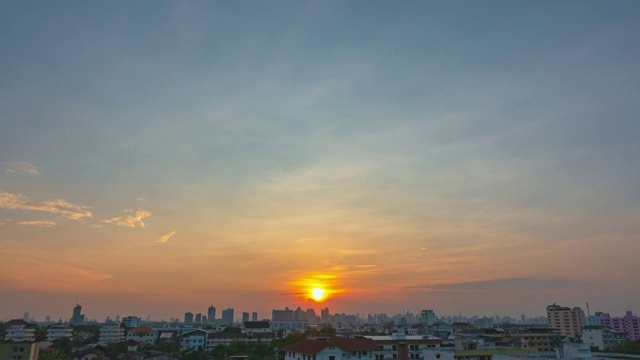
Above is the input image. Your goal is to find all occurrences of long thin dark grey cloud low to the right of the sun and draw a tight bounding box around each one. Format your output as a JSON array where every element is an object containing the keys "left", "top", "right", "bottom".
[{"left": 407, "top": 277, "right": 580, "bottom": 291}]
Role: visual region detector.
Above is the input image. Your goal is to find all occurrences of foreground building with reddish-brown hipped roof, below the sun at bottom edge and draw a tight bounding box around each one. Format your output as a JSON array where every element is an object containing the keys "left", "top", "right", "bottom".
[{"left": 281, "top": 338, "right": 377, "bottom": 360}]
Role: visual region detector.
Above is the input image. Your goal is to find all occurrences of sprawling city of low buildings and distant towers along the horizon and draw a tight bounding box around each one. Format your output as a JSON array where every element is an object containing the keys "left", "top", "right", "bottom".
[{"left": 0, "top": 304, "right": 640, "bottom": 360}]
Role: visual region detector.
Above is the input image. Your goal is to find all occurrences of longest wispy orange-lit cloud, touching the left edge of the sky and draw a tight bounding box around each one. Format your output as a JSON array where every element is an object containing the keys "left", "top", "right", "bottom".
[{"left": 0, "top": 192, "right": 93, "bottom": 220}]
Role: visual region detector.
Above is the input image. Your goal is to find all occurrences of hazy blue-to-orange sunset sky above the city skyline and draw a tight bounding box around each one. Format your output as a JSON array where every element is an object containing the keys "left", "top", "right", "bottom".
[{"left": 0, "top": 0, "right": 640, "bottom": 321}]
